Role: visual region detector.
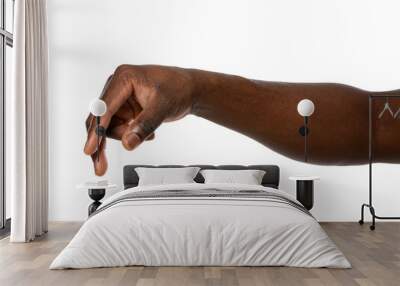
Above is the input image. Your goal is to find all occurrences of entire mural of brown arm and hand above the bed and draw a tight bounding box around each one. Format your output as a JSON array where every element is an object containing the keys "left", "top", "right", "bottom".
[{"left": 84, "top": 65, "right": 400, "bottom": 175}]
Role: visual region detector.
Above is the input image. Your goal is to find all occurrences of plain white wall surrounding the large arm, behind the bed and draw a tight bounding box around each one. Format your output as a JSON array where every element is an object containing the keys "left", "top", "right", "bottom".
[{"left": 48, "top": 0, "right": 400, "bottom": 221}]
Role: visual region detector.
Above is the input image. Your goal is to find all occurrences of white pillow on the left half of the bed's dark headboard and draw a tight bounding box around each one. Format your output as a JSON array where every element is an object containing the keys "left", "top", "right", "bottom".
[{"left": 135, "top": 167, "right": 200, "bottom": 186}]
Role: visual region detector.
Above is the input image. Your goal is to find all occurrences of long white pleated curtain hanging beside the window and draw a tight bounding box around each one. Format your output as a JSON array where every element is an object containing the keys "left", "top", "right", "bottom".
[{"left": 6, "top": 0, "right": 48, "bottom": 242}]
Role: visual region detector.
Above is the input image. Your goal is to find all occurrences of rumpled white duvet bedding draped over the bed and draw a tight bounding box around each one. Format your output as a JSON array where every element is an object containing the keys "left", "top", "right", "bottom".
[{"left": 50, "top": 183, "right": 351, "bottom": 269}]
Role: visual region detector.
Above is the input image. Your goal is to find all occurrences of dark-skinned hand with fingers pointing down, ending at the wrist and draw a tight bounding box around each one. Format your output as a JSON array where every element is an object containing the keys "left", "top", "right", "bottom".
[{"left": 84, "top": 65, "right": 193, "bottom": 176}]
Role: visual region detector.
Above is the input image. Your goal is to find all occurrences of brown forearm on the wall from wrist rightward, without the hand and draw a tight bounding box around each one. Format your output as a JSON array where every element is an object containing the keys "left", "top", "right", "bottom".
[{"left": 188, "top": 70, "right": 400, "bottom": 165}]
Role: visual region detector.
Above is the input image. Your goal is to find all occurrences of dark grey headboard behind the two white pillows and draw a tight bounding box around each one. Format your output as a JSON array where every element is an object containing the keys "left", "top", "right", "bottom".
[{"left": 124, "top": 165, "right": 279, "bottom": 189}]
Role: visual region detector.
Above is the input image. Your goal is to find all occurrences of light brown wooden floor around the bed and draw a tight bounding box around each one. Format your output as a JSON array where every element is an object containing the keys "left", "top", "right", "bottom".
[{"left": 0, "top": 222, "right": 400, "bottom": 286}]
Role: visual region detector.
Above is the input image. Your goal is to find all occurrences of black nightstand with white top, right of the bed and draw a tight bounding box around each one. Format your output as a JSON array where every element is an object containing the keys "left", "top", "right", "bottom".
[{"left": 289, "top": 176, "right": 319, "bottom": 210}]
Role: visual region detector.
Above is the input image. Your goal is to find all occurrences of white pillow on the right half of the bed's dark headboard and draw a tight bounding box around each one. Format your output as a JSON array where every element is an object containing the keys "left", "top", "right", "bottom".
[{"left": 200, "top": 170, "right": 265, "bottom": 185}]
